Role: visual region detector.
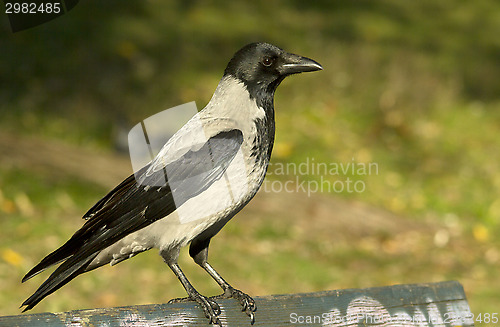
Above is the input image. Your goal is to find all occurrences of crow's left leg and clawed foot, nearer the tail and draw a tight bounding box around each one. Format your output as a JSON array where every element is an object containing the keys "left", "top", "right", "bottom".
[{"left": 162, "top": 253, "right": 222, "bottom": 326}]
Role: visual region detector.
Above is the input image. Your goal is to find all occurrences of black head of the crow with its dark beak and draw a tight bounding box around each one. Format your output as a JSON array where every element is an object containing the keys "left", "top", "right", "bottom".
[{"left": 224, "top": 43, "right": 323, "bottom": 98}]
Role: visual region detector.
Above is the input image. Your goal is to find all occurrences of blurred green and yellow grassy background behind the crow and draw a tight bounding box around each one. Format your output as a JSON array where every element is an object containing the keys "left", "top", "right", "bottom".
[{"left": 0, "top": 0, "right": 500, "bottom": 325}]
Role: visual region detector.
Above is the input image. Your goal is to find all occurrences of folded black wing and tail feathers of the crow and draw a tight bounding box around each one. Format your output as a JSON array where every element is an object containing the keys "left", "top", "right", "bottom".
[{"left": 22, "top": 129, "right": 243, "bottom": 311}]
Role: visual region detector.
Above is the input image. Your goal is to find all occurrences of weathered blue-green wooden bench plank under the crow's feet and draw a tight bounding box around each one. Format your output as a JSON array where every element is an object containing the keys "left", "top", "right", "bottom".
[{"left": 0, "top": 281, "right": 473, "bottom": 327}]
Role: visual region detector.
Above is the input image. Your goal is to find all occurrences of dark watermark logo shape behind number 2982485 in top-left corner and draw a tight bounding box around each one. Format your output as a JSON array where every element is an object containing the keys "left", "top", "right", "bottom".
[{"left": 3, "top": 0, "right": 79, "bottom": 33}]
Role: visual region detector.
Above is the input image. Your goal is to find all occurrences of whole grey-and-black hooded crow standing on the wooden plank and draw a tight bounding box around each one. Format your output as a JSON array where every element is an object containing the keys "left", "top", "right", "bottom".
[{"left": 22, "top": 43, "right": 323, "bottom": 325}]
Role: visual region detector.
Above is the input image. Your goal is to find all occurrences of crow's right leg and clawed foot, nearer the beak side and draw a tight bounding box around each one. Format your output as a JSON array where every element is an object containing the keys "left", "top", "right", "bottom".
[{"left": 189, "top": 240, "right": 257, "bottom": 325}]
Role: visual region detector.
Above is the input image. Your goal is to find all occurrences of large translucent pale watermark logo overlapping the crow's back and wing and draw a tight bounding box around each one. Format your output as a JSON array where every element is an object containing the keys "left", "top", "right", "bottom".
[{"left": 128, "top": 102, "right": 248, "bottom": 223}]
